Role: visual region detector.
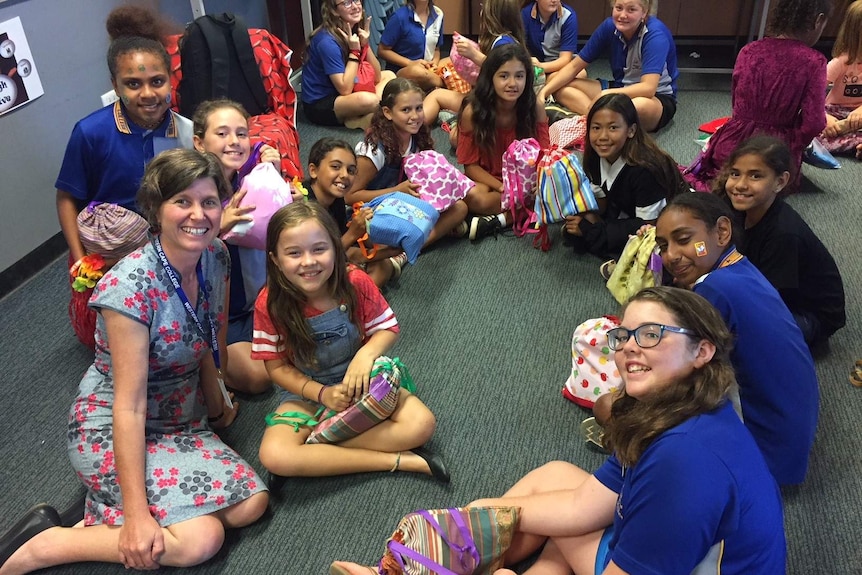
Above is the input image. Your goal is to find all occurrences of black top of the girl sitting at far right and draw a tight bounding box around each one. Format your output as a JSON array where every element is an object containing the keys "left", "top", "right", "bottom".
[{"left": 739, "top": 198, "right": 846, "bottom": 337}]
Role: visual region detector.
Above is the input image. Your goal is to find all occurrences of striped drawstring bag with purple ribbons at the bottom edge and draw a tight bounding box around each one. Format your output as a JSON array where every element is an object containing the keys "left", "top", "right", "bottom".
[{"left": 378, "top": 507, "right": 520, "bottom": 575}]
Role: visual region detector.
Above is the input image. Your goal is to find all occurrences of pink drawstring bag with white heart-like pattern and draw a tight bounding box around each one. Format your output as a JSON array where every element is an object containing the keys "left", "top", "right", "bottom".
[{"left": 404, "top": 150, "right": 476, "bottom": 212}]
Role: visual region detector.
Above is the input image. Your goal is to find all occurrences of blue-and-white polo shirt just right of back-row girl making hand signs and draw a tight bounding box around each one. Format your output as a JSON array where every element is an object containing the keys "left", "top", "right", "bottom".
[{"left": 380, "top": 5, "right": 443, "bottom": 72}]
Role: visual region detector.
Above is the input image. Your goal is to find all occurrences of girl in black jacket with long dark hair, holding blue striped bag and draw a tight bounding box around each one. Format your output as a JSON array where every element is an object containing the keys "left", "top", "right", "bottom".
[{"left": 563, "top": 94, "right": 688, "bottom": 266}]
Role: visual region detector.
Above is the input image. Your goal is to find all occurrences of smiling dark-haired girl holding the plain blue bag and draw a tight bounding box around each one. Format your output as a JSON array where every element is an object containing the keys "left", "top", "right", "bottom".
[{"left": 303, "top": 138, "right": 407, "bottom": 288}]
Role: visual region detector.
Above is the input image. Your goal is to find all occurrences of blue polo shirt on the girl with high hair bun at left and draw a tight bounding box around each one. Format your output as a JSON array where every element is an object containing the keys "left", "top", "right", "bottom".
[{"left": 54, "top": 101, "right": 192, "bottom": 212}]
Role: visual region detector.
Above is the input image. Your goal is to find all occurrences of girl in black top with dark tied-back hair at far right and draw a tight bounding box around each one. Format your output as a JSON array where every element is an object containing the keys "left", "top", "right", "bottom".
[{"left": 720, "top": 136, "right": 847, "bottom": 346}]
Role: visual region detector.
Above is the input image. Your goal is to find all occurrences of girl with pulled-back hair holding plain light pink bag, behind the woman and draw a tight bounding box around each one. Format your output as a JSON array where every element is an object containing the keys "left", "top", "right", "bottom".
[{"left": 192, "top": 99, "right": 290, "bottom": 393}]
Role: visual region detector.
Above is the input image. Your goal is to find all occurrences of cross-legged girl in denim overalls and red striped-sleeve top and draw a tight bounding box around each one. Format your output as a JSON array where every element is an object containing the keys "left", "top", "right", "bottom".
[{"left": 252, "top": 202, "right": 448, "bottom": 481}]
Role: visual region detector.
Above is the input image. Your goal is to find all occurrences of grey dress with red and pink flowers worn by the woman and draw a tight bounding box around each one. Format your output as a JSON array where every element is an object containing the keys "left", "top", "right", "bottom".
[{"left": 67, "top": 240, "right": 266, "bottom": 527}]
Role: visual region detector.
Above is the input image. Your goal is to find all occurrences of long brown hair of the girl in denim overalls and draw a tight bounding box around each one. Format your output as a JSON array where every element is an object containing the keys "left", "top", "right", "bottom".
[{"left": 266, "top": 201, "right": 364, "bottom": 368}]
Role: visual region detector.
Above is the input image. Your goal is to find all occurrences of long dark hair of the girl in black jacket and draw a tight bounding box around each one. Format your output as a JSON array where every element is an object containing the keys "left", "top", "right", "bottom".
[{"left": 584, "top": 93, "right": 689, "bottom": 199}]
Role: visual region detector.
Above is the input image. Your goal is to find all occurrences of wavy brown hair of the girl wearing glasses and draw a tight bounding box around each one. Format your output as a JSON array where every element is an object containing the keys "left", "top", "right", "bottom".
[{"left": 605, "top": 287, "right": 736, "bottom": 466}]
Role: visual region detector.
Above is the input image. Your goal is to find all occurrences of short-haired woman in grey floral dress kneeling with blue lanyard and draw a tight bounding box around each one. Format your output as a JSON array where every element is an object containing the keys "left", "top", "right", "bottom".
[{"left": 0, "top": 150, "right": 268, "bottom": 575}]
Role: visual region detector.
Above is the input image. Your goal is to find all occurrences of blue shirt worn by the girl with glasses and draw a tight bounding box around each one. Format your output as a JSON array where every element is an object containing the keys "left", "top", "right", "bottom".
[{"left": 595, "top": 402, "right": 786, "bottom": 575}]
